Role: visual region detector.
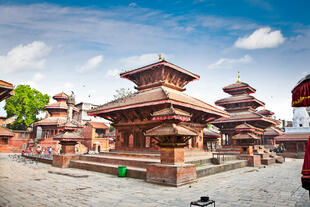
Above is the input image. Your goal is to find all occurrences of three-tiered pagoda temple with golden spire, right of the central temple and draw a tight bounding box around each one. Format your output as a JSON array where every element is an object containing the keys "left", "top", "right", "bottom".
[{"left": 212, "top": 75, "right": 278, "bottom": 146}]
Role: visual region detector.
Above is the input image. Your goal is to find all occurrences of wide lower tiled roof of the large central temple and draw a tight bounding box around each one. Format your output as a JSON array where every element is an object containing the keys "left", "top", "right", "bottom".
[{"left": 88, "top": 83, "right": 229, "bottom": 121}]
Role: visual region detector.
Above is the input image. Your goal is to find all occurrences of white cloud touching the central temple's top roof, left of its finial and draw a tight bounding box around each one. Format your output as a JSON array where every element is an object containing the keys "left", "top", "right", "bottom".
[{"left": 121, "top": 53, "right": 161, "bottom": 70}]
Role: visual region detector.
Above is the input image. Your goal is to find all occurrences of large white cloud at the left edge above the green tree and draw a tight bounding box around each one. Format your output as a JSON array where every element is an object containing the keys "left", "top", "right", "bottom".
[{"left": 0, "top": 41, "right": 51, "bottom": 73}]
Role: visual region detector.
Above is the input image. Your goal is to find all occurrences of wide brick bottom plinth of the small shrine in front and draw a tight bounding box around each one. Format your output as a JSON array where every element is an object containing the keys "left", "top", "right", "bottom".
[{"left": 146, "top": 164, "right": 197, "bottom": 187}]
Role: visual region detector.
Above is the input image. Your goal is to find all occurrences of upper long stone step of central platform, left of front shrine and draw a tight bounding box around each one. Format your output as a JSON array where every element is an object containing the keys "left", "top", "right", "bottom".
[{"left": 79, "top": 155, "right": 160, "bottom": 168}]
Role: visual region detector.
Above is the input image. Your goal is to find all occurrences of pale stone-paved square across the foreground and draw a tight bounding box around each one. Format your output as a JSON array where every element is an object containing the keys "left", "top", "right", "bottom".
[{"left": 0, "top": 154, "right": 310, "bottom": 207}]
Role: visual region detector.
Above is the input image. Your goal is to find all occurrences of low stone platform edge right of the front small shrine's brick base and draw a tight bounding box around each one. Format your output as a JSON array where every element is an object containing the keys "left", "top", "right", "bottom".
[{"left": 196, "top": 160, "right": 248, "bottom": 178}]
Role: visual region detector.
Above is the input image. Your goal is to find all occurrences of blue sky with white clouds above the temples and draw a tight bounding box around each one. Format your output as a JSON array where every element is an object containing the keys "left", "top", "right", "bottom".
[{"left": 0, "top": 0, "right": 310, "bottom": 119}]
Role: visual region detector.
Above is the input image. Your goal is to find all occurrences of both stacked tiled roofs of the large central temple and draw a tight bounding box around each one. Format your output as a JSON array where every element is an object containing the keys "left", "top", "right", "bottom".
[{"left": 88, "top": 60, "right": 228, "bottom": 122}]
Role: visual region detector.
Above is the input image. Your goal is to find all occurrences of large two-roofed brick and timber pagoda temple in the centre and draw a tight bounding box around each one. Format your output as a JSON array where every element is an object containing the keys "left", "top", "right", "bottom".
[{"left": 88, "top": 59, "right": 228, "bottom": 151}]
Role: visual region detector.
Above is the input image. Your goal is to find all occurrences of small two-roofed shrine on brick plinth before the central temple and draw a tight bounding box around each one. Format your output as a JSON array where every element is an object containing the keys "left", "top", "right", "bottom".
[{"left": 145, "top": 104, "right": 198, "bottom": 186}]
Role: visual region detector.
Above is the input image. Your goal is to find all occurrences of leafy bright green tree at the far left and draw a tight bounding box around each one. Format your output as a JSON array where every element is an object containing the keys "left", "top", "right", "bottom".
[{"left": 4, "top": 85, "right": 50, "bottom": 130}]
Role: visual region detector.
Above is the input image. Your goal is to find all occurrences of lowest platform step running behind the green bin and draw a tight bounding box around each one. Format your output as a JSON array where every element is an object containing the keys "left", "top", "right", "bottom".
[{"left": 69, "top": 160, "right": 146, "bottom": 179}]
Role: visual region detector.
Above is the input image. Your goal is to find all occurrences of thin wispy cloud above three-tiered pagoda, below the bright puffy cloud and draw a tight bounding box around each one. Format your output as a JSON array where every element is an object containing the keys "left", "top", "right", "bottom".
[{"left": 208, "top": 55, "right": 253, "bottom": 69}]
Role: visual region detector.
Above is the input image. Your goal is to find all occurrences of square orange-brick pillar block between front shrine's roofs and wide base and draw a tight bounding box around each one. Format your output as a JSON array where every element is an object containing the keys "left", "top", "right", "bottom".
[{"left": 160, "top": 147, "right": 184, "bottom": 165}]
